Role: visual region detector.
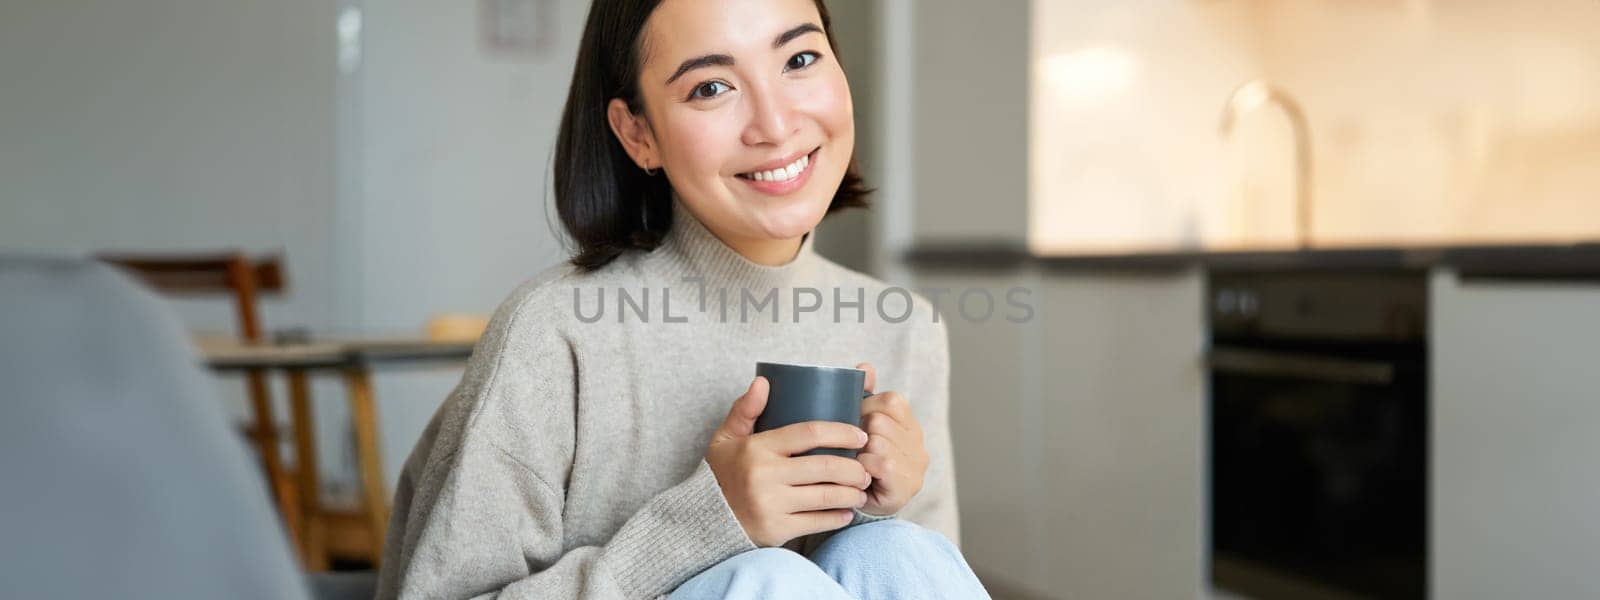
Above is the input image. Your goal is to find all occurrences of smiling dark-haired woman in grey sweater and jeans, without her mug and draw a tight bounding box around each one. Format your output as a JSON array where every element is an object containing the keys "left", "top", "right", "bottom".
[{"left": 379, "top": 0, "right": 986, "bottom": 600}]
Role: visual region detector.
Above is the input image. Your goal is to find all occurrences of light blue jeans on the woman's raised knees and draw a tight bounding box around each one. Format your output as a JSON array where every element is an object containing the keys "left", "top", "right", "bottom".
[{"left": 667, "top": 518, "right": 989, "bottom": 600}]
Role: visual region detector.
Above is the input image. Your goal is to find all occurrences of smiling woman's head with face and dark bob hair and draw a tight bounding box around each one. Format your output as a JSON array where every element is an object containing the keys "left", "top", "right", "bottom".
[{"left": 555, "top": 0, "right": 867, "bottom": 269}]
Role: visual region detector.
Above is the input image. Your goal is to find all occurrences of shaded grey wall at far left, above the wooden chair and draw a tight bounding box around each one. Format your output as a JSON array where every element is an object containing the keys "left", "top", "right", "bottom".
[{"left": 0, "top": 0, "right": 353, "bottom": 472}]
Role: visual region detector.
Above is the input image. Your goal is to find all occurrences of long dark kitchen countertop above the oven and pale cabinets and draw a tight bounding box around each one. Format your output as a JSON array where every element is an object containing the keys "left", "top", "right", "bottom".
[{"left": 904, "top": 242, "right": 1600, "bottom": 282}]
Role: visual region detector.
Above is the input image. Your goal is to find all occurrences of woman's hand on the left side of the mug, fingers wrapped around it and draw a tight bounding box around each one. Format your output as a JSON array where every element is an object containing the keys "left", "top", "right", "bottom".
[{"left": 706, "top": 378, "right": 870, "bottom": 547}]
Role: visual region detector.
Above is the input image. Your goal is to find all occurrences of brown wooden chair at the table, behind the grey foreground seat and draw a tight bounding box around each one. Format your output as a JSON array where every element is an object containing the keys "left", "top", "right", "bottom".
[{"left": 96, "top": 251, "right": 304, "bottom": 547}]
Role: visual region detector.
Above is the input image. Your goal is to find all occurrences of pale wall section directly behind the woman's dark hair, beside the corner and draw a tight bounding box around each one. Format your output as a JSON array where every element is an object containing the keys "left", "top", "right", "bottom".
[{"left": 353, "top": 0, "right": 589, "bottom": 488}]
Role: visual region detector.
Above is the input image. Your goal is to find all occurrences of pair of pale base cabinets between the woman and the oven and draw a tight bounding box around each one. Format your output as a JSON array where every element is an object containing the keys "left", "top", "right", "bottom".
[{"left": 918, "top": 270, "right": 1205, "bottom": 598}]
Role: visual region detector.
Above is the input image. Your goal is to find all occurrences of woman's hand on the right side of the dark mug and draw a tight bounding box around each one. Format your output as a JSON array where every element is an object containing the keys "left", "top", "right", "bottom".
[{"left": 856, "top": 363, "right": 928, "bottom": 515}]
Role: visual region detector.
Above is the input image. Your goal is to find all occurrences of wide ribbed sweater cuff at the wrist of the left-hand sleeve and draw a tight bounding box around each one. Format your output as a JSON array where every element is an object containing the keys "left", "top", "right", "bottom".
[{"left": 605, "top": 459, "right": 755, "bottom": 598}]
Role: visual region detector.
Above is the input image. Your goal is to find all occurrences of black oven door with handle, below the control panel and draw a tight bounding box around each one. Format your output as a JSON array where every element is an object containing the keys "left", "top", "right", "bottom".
[{"left": 1210, "top": 344, "right": 1427, "bottom": 598}]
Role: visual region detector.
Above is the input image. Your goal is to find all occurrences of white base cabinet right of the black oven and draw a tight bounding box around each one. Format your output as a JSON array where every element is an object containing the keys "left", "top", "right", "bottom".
[{"left": 1430, "top": 272, "right": 1600, "bottom": 598}]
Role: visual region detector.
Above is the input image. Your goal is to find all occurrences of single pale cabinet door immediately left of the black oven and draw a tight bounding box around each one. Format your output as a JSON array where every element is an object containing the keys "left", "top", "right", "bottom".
[{"left": 1037, "top": 270, "right": 1206, "bottom": 598}]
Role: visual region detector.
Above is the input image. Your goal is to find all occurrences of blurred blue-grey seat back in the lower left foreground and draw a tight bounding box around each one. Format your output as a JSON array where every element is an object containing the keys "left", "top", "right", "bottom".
[{"left": 0, "top": 254, "right": 374, "bottom": 598}]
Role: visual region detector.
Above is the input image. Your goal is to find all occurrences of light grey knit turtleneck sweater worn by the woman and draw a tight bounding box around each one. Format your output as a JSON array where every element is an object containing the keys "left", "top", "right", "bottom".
[{"left": 378, "top": 203, "right": 960, "bottom": 598}]
